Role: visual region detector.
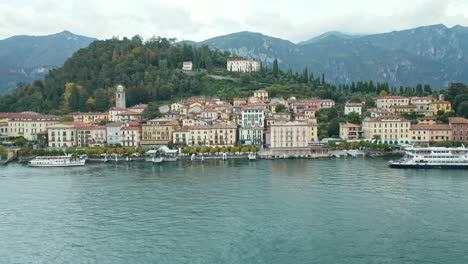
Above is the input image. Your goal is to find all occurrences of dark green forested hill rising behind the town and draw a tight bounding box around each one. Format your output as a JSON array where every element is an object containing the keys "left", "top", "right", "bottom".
[{"left": 0, "top": 36, "right": 464, "bottom": 117}]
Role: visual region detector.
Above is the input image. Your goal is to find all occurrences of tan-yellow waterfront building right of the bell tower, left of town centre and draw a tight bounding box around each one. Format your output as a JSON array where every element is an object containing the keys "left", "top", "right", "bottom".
[{"left": 140, "top": 118, "right": 179, "bottom": 146}]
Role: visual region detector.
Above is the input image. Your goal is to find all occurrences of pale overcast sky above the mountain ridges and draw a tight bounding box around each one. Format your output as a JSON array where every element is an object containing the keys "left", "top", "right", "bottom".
[{"left": 0, "top": 0, "right": 468, "bottom": 42}]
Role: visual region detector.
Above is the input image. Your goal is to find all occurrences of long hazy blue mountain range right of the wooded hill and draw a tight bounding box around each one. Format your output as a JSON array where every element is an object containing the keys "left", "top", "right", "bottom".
[{"left": 189, "top": 24, "right": 468, "bottom": 89}]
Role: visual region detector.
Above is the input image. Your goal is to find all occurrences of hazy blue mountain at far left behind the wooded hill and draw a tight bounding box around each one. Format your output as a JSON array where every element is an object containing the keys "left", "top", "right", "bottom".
[{"left": 0, "top": 31, "right": 95, "bottom": 94}]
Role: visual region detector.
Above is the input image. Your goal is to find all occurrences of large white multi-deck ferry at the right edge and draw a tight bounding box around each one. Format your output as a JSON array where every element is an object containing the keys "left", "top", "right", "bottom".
[{"left": 389, "top": 146, "right": 468, "bottom": 169}]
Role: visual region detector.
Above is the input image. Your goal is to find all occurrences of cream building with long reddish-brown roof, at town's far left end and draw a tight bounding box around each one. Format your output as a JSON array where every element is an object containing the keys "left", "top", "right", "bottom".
[{"left": 0, "top": 112, "right": 60, "bottom": 140}]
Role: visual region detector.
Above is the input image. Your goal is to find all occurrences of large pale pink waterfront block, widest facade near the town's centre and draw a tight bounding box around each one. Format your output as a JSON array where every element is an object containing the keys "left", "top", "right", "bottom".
[{"left": 270, "top": 121, "right": 318, "bottom": 149}]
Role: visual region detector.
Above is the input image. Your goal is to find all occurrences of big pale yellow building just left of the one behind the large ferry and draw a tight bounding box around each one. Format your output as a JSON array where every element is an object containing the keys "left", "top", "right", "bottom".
[{"left": 362, "top": 115, "right": 410, "bottom": 144}]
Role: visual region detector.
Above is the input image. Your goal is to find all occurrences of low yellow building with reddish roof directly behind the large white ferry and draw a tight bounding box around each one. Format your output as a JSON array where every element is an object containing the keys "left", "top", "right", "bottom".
[{"left": 410, "top": 124, "right": 452, "bottom": 145}]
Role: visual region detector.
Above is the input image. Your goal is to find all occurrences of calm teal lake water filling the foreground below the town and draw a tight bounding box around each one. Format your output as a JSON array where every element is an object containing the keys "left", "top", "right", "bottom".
[{"left": 0, "top": 159, "right": 468, "bottom": 264}]
